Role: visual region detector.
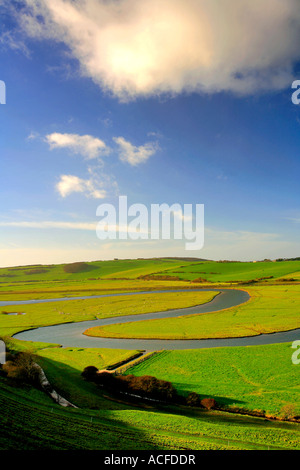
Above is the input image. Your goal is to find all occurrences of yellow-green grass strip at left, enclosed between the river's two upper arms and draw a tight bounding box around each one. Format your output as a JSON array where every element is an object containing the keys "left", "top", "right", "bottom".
[{"left": 0, "top": 291, "right": 217, "bottom": 337}]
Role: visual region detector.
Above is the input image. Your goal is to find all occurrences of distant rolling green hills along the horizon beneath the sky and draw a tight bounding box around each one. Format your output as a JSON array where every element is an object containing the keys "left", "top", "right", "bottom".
[{"left": 0, "top": 259, "right": 300, "bottom": 300}]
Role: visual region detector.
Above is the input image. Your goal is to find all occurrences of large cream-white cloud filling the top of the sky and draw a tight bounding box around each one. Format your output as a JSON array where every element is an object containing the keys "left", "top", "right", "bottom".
[{"left": 14, "top": 0, "right": 300, "bottom": 99}]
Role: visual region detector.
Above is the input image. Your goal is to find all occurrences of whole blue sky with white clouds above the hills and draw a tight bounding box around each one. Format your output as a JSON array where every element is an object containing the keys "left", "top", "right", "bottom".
[{"left": 0, "top": 0, "right": 300, "bottom": 267}]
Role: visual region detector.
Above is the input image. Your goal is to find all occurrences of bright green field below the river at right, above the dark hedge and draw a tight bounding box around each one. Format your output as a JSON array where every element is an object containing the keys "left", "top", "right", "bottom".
[{"left": 126, "top": 343, "right": 300, "bottom": 417}]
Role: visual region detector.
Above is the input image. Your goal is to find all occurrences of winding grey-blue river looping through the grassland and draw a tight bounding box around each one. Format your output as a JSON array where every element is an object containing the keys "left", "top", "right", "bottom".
[{"left": 7, "top": 289, "right": 300, "bottom": 351}]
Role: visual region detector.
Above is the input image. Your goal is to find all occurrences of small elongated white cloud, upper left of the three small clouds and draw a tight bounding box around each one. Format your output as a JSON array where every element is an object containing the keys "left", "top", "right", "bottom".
[{"left": 45, "top": 132, "right": 109, "bottom": 159}]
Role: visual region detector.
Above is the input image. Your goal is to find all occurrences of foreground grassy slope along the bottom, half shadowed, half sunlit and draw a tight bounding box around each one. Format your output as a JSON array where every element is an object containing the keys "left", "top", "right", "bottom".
[{"left": 0, "top": 377, "right": 300, "bottom": 451}]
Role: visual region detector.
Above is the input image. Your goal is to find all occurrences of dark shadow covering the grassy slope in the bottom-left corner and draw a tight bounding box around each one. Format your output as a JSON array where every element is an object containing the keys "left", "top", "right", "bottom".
[{"left": 0, "top": 350, "right": 166, "bottom": 451}]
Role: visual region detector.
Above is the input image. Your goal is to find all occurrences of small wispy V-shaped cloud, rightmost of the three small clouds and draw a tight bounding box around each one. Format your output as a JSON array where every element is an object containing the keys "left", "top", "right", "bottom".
[{"left": 113, "top": 137, "right": 158, "bottom": 166}]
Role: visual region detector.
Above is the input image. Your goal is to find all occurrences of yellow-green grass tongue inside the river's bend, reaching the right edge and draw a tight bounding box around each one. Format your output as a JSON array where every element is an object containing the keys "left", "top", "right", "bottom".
[{"left": 83, "top": 284, "right": 300, "bottom": 339}]
